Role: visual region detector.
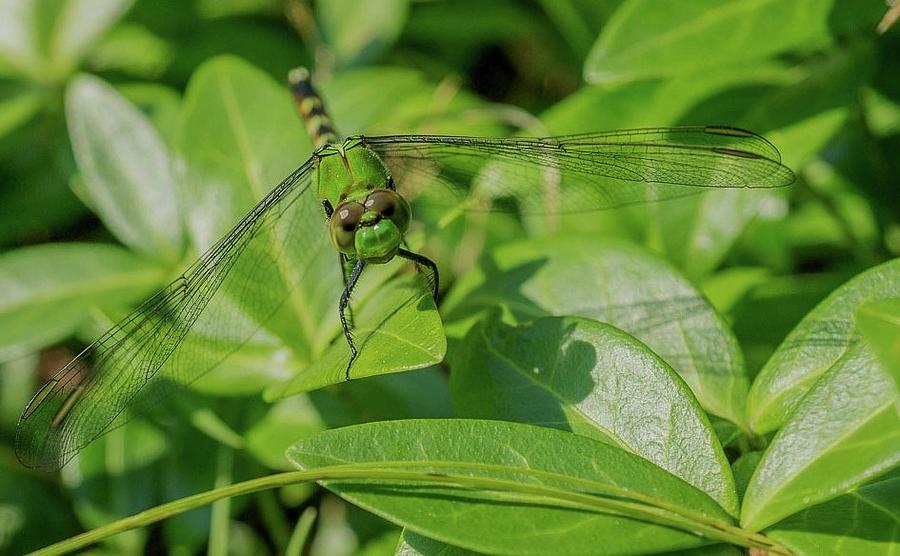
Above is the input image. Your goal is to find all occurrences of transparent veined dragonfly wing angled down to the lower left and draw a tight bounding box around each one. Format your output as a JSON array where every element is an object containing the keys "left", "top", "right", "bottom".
[{"left": 16, "top": 161, "right": 339, "bottom": 469}]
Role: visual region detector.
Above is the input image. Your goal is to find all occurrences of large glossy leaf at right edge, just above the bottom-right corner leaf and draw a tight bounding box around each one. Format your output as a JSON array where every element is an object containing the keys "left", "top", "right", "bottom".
[{"left": 741, "top": 341, "right": 900, "bottom": 531}]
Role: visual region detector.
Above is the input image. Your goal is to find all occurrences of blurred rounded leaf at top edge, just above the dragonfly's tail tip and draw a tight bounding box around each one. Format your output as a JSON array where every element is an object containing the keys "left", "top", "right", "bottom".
[{"left": 316, "top": 0, "right": 409, "bottom": 66}]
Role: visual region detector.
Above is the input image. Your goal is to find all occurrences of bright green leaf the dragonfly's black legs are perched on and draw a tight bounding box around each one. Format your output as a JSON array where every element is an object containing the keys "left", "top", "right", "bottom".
[{"left": 265, "top": 276, "right": 447, "bottom": 400}]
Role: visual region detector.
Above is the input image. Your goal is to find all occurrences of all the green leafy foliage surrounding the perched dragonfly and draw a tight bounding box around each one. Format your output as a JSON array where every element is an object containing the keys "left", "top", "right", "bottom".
[{"left": 0, "top": 0, "right": 900, "bottom": 555}]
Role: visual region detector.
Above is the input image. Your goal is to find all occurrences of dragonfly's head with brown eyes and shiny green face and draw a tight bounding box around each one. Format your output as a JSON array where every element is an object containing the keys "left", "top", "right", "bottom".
[{"left": 328, "top": 189, "right": 411, "bottom": 263}]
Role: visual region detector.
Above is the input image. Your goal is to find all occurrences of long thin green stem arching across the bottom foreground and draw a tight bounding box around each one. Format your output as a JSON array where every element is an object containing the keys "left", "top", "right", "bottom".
[{"left": 33, "top": 462, "right": 791, "bottom": 556}]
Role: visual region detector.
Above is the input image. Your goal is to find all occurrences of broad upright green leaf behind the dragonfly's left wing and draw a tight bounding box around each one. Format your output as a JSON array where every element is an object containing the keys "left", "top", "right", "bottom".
[{"left": 177, "top": 56, "right": 324, "bottom": 363}]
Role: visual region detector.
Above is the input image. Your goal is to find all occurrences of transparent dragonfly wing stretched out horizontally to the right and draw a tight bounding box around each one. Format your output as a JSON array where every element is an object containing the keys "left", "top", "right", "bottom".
[{"left": 365, "top": 126, "right": 794, "bottom": 214}]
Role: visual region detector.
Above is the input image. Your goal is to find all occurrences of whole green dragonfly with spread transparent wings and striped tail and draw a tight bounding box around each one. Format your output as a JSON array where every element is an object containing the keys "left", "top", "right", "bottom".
[{"left": 16, "top": 69, "right": 794, "bottom": 469}]
